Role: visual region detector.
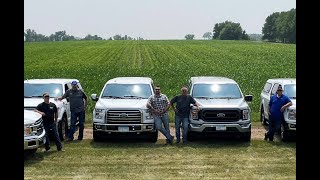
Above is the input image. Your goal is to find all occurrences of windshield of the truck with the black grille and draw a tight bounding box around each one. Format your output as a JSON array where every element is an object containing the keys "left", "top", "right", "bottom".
[{"left": 192, "top": 84, "right": 242, "bottom": 99}]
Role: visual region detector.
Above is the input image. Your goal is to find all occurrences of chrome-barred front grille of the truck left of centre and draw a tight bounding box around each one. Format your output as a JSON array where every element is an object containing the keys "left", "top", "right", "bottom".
[{"left": 107, "top": 110, "right": 141, "bottom": 124}]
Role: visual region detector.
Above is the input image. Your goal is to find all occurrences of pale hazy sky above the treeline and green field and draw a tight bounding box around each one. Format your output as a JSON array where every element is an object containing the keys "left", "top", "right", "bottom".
[{"left": 24, "top": 0, "right": 296, "bottom": 40}]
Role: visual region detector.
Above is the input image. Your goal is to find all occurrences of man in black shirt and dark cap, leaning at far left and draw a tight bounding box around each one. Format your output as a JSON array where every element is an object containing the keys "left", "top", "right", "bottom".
[{"left": 35, "top": 92, "right": 62, "bottom": 151}]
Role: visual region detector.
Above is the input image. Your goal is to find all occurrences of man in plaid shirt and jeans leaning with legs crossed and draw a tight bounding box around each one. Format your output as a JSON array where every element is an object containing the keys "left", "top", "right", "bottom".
[{"left": 147, "top": 86, "right": 173, "bottom": 144}]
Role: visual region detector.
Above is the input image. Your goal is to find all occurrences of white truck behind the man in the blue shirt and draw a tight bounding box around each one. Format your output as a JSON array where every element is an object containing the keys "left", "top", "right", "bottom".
[{"left": 260, "top": 78, "right": 296, "bottom": 141}]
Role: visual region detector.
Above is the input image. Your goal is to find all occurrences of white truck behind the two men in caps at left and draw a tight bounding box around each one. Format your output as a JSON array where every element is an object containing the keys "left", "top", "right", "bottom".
[{"left": 24, "top": 79, "right": 83, "bottom": 141}]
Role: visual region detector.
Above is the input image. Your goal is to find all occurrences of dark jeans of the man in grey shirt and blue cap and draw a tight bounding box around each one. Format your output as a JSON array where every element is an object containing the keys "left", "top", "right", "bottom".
[{"left": 69, "top": 111, "right": 85, "bottom": 140}]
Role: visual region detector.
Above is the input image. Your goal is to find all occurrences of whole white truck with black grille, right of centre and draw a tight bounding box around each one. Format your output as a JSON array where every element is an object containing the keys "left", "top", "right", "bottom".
[{"left": 188, "top": 76, "right": 252, "bottom": 141}]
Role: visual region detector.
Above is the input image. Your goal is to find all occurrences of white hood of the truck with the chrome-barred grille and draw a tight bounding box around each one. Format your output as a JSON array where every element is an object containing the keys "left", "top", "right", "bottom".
[{"left": 96, "top": 99, "right": 148, "bottom": 109}]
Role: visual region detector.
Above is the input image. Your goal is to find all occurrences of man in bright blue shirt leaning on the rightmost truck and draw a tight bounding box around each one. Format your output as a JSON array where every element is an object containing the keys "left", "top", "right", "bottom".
[{"left": 264, "top": 85, "right": 292, "bottom": 141}]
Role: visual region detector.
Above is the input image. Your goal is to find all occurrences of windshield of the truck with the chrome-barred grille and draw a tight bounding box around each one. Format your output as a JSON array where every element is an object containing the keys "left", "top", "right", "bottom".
[{"left": 101, "top": 84, "right": 152, "bottom": 99}]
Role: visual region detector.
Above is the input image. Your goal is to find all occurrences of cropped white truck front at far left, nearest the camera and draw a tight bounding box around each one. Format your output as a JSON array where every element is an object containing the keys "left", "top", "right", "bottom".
[{"left": 24, "top": 110, "right": 46, "bottom": 155}]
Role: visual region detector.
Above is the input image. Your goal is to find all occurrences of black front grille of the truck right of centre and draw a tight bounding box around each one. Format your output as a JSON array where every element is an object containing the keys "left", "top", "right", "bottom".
[{"left": 199, "top": 110, "right": 241, "bottom": 122}]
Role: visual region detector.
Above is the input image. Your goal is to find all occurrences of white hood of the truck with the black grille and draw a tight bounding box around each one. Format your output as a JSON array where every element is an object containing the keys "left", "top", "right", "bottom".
[{"left": 195, "top": 98, "right": 249, "bottom": 108}]
